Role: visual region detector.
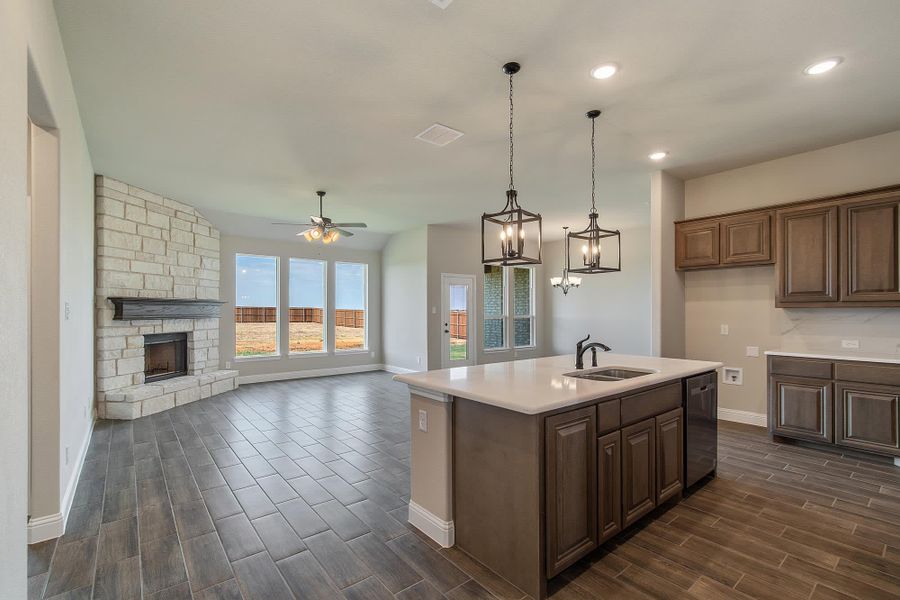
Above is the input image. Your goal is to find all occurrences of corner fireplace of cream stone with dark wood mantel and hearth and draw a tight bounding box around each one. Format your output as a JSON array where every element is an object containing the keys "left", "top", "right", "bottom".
[{"left": 95, "top": 175, "right": 237, "bottom": 419}]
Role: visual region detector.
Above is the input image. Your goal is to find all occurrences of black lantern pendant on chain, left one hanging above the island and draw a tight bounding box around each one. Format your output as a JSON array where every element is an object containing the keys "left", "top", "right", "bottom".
[{"left": 481, "top": 62, "right": 541, "bottom": 266}]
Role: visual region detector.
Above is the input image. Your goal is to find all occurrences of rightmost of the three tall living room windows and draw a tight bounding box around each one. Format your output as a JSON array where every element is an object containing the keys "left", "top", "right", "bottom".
[{"left": 334, "top": 262, "right": 368, "bottom": 351}]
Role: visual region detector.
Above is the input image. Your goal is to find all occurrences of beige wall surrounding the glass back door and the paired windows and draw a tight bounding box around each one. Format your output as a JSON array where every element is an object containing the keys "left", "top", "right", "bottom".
[{"left": 427, "top": 225, "right": 549, "bottom": 369}]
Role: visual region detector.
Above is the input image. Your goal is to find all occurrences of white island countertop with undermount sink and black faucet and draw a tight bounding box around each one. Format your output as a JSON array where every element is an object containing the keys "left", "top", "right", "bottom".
[{"left": 394, "top": 352, "right": 722, "bottom": 415}]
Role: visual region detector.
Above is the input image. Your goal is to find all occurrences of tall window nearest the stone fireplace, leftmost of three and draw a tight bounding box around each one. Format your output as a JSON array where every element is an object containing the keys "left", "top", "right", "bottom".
[{"left": 234, "top": 254, "right": 278, "bottom": 358}]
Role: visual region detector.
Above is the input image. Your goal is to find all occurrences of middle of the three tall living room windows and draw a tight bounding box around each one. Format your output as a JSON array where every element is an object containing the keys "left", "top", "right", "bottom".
[{"left": 289, "top": 258, "right": 326, "bottom": 354}]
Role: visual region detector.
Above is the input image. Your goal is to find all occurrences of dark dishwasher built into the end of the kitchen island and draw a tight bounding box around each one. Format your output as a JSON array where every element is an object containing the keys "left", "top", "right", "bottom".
[{"left": 684, "top": 371, "right": 719, "bottom": 488}]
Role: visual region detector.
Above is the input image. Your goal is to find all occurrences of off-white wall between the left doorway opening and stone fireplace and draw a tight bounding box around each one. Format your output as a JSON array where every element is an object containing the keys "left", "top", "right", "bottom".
[{"left": 26, "top": 0, "right": 94, "bottom": 540}]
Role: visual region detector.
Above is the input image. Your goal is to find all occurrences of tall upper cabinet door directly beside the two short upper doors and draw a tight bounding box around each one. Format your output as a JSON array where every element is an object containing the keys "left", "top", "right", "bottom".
[{"left": 776, "top": 205, "right": 839, "bottom": 305}]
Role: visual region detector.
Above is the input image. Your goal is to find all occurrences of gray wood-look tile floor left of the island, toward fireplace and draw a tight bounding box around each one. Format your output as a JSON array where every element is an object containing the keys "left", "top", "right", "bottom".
[{"left": 28, "top": 373, "right": 522, "bottom": 600}]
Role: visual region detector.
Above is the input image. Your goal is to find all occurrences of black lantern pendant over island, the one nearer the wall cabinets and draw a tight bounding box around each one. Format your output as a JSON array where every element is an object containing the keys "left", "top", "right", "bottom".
[{"left": 566, "top": 110, "right": 622, "bottom": 275}]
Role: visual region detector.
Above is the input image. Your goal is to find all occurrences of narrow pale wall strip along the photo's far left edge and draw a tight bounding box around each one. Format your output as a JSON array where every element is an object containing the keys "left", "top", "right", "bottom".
[{"left": 0, "top": 0, "right": 29, "bottom": 598}]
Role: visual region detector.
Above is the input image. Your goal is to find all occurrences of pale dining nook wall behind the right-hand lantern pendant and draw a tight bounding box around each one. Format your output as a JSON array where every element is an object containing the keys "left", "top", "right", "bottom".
[{"left": 541, "top": 224, "right": 653, "bottom": 355}]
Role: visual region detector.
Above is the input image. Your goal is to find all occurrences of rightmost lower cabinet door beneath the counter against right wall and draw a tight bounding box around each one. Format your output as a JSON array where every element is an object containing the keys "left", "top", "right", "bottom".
[{"left": 834, "top": 382, "right": 900, "bottom": 456}]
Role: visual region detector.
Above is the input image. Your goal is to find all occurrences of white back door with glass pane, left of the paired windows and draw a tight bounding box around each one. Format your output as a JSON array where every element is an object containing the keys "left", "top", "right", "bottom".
[{"left": 441, "top": 273, "right": 475, "bottom": 369}]
